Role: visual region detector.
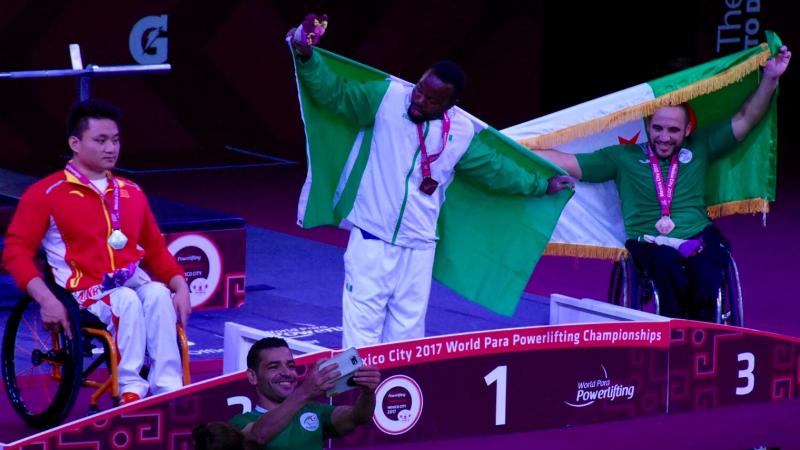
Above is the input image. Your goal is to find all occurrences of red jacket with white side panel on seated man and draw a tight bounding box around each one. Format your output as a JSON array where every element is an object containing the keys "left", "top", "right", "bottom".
[{"left": 3, "top": 170, "right": 184, "bottom": 291}]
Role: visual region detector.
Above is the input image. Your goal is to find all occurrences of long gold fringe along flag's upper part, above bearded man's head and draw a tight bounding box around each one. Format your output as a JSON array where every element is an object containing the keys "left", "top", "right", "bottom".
[{"left": 517, "top": 43, "right": 771, "bottom": 150}]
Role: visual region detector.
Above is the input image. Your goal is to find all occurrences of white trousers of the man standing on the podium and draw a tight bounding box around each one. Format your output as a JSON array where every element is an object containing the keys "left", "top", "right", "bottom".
[{"left": 342, "top": 227, "right": 436, "bottom": 348}]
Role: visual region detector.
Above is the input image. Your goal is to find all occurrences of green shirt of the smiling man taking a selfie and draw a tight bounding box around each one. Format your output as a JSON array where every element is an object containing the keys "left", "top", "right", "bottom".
[{"left": 228, "top": 403, "right": 339, "bottom": 450}]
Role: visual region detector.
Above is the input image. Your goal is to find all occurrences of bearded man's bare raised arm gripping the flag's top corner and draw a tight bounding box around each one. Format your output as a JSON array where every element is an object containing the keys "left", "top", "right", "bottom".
[{"left": 731, "top": 45, "right": 792, "bottom": 141}]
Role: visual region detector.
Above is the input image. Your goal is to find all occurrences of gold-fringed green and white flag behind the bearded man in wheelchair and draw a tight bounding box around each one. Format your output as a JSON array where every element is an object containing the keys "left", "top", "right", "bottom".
[{"left": 503, "top": 31, "right": 781, "bottom": 259}]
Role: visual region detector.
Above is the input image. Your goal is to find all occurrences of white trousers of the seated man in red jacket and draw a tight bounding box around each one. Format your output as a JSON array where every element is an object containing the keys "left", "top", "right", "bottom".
[{"left": 87, "top": 270, "right": 183, "bottom": 398}]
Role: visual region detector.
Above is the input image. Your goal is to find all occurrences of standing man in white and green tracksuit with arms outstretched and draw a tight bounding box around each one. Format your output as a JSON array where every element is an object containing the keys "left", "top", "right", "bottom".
[{"left": 295, "top": 34, "right": 569, "bottom": 347}]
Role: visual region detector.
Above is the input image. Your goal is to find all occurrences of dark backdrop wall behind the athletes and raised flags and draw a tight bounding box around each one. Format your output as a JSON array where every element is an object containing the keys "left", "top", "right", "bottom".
[{"left": 0, "top": 0, "right": 800, "bottom": 183}]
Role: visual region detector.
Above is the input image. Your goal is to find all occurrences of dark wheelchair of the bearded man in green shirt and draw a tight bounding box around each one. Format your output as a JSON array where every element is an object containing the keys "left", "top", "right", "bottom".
[{"left": 608, "top": 244, "right": 744, "bottom": 327}]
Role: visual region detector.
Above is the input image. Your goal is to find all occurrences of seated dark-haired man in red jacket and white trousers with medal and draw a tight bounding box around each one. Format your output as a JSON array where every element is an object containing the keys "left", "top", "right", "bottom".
[{"left": 3, "top": 100, "right": 191, "bottom": 402}]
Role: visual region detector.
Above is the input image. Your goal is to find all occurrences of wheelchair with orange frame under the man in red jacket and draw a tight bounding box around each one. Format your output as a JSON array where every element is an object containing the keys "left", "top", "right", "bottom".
[{"left": 2, "top": 280, "right": 190, "bottom": 429}]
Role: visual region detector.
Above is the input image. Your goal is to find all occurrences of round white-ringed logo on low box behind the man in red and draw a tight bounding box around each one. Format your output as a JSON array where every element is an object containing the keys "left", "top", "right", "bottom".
[{"left": 168, "top": 234, "right": 222, "bottom": 307}]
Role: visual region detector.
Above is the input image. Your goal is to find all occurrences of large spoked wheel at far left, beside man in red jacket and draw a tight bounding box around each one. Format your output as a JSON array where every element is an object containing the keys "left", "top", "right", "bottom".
[{"left": 2, "top": 297, "right": 83, "bottom": 428}]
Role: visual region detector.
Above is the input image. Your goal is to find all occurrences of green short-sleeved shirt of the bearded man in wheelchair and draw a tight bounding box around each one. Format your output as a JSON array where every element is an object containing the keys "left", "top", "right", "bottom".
[{"left": 576, "top": 121, "right": 737, "bottom": 239}]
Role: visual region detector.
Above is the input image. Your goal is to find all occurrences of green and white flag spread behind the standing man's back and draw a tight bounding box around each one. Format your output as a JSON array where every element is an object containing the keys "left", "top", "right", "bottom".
[{"left": 297, "top": 48, "right": 570, "bottom": 315}]
